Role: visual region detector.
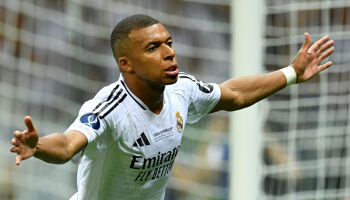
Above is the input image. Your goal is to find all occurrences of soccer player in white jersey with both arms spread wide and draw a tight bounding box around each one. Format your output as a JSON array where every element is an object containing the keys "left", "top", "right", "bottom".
[{"left": 10, "top": 15, "right": 334, "bottom": 200}]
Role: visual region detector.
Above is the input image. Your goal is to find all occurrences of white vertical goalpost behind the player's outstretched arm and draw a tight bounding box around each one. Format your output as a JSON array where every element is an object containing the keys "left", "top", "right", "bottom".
[{"left": 230, "top": 0, "right": 265, "bottom": 200}]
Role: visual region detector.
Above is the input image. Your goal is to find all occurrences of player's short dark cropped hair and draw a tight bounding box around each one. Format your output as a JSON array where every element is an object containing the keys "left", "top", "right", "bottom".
[{"left": 111, "top": 14, "right": 160, "bottom": 63}]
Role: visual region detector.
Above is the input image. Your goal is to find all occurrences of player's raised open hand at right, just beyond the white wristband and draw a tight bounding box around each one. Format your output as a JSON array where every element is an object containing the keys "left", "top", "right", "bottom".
[{"left": 291, "top": 33, "right": 334, "bottom": 83}]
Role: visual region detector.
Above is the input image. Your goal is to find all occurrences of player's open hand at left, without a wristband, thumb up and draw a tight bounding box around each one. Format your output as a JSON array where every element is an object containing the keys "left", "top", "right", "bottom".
[{"left": 10, "top": 116, "right": 39, "bottom": 165}]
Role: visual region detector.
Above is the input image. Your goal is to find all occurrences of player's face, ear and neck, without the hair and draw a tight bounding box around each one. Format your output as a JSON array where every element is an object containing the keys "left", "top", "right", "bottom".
[{"left": 118, "top": 24, "right": 178, "bottom": 114}]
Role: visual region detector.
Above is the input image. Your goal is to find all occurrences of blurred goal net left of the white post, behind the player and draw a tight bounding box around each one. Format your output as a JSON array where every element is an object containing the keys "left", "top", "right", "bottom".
[{"left": 0, "top": 0, "right": 230, "bottom": 200}]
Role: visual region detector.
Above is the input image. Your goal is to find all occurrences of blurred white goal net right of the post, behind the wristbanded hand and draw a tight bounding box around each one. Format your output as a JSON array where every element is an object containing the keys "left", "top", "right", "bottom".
[{"left": 259, "top": 0, "right": 350, "bottom": 200}]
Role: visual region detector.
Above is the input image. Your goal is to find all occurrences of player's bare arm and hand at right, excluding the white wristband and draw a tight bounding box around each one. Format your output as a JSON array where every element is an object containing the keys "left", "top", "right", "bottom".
[{"left": 211, "top": 33, "right": 334, "bottom": 112}]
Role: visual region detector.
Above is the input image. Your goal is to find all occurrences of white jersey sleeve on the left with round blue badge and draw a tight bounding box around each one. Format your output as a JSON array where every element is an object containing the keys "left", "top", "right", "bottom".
[{"left": 66, "top": 100, "right": 108, "bottom": 143}]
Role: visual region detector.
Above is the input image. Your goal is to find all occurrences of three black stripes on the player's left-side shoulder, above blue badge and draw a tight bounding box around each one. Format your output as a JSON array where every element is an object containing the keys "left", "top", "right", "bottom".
[{"left": 92, "top": 84, "right": 128, "bottom": 119}]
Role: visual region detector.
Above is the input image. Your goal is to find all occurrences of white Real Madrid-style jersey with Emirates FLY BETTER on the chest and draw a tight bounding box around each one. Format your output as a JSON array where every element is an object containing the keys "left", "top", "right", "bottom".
[{"left": 67, "top": 73, "right": 220, "bottom": 200}]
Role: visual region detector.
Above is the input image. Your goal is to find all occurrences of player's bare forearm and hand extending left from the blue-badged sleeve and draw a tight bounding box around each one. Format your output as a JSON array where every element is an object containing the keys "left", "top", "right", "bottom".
[{"left": 10, "top": 116, "right": 88, "bottom": 165}]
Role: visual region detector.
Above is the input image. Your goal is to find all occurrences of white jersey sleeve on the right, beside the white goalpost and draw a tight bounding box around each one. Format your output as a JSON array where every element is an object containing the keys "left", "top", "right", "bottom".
[{"left": 179, "top": 73, "right": 221, "bottom": 124}]
